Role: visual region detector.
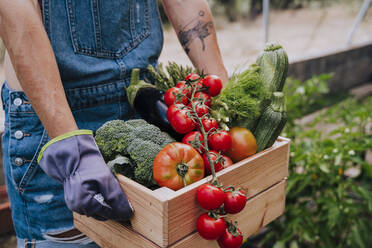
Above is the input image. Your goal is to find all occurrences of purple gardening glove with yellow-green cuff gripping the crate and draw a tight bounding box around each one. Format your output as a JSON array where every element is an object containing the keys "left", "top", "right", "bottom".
[{"left": 38, "top": 130, "right": 133, "bottom": 220}]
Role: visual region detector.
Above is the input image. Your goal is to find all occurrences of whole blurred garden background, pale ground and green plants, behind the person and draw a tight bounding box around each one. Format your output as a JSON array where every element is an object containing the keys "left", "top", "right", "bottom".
[{"left": 0, "top": 0, "right": 372, "bottom": 248}]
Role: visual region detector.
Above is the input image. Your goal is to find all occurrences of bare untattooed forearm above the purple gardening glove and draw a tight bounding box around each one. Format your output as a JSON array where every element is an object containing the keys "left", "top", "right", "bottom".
[{"left": 0, "top": 0, "right": 77, "bottom": 138}]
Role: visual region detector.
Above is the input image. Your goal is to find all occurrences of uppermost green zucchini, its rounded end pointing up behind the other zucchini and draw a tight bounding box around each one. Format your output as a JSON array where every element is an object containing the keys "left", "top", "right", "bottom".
[{"left": 256, "top": 43, "right": 288, "bottom": 92}]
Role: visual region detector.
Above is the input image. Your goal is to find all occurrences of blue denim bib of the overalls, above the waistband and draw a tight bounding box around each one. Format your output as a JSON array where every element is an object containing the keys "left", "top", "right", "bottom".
[{"left": 42, "top": 0, "right": 163, "bottom": 89}]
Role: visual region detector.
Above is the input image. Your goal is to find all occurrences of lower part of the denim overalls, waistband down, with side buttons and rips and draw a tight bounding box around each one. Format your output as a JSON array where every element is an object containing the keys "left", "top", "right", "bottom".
[{"left": 1, "top": 80, "right": 133, "bottom": 248}]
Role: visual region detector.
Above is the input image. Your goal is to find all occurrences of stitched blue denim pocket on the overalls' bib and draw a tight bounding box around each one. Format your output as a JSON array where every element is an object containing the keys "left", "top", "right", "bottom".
[{"left": 66, "top": 0, "right": 153, "bottom": 58}]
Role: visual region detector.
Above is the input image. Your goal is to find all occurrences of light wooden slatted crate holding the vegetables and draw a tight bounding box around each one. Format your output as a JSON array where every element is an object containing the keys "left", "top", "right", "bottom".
[{"left": 75, "top": 138, "right": 289, "bottom": 248}]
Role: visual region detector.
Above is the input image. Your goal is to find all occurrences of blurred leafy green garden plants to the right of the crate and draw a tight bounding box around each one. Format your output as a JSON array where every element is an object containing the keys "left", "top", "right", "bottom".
[{"left": 244, "top": 76, "right": 372, "bottom": 248}]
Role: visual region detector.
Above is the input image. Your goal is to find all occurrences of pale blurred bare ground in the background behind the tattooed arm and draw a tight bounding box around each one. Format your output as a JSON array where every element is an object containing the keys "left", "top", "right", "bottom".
[{"left": 0, "top": 5, "right": 372, "bottom": 248}]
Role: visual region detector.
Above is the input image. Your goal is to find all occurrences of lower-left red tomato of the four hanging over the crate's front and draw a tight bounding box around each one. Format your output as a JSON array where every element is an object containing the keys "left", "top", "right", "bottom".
[{"left": 196, "top": 213, "right": 226, "bottom": 240}]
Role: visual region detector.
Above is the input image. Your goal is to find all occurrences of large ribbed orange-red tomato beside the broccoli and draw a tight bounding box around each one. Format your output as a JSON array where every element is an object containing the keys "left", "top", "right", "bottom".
[{"left": 153, "top": 142, "right": 204, "bottom": 190}]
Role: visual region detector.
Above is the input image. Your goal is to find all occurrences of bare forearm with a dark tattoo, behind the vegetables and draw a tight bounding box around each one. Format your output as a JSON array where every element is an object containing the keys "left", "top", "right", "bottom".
[{"left": 163, "top": 0, "right": 227, "bottom": 83}]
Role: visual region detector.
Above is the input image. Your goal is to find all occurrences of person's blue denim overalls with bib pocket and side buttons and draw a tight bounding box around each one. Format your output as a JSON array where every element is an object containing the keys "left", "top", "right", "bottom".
[{"left": 1, "top": 0, "right": 163, "bottom": 248}]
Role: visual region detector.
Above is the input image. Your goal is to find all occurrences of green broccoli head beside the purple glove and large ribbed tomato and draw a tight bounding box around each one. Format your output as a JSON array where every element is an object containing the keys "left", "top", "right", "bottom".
[{"left": 95, "top": 119, "right": 175, "bottom": 187}]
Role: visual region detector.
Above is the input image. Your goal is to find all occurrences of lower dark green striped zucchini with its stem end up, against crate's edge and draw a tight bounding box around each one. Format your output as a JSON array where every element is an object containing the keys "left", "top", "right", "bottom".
[{"left": 254, "top": 92, "right": 287, "bottom": 152}]
